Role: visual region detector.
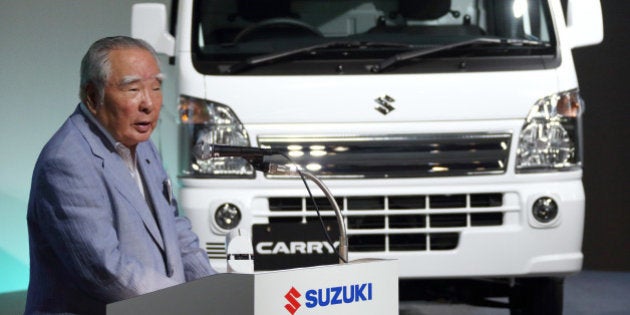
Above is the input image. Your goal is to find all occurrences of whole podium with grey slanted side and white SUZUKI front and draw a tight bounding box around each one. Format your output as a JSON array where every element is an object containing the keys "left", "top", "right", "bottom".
[{"left": 107, "top": 259, "right": 398, "bottom": 315}]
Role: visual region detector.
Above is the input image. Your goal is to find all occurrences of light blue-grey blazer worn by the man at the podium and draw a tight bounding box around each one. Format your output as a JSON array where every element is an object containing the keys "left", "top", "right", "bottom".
[{"left": 26, "top": 107, "right": 214, "bottom": 314}]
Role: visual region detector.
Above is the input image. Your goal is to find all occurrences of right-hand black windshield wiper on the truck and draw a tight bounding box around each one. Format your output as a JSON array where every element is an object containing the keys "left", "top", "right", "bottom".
[{"left": 371, "top": 37, "right": 550, "bottom": 73}]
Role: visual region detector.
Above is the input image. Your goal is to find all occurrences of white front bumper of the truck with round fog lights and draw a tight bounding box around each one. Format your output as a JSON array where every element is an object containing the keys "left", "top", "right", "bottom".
[{"left": 180, "top": 172, "right": 584, "bottom": 278}]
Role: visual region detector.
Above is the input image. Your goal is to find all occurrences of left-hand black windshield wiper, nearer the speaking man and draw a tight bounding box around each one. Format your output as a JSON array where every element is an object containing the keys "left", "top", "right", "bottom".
[{"left": 221, "top": 41, "right": 413, "bottom": 74}]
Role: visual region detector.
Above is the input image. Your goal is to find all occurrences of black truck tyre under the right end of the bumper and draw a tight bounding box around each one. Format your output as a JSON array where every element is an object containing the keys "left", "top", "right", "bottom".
[{"left": 510, "top": 278, "right": 564, "bottom": 315}]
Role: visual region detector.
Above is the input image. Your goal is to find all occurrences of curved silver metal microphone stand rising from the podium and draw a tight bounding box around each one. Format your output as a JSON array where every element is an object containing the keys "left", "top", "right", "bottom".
[{"left": 267, "top": 163, "right": 348, "bottom": 264}]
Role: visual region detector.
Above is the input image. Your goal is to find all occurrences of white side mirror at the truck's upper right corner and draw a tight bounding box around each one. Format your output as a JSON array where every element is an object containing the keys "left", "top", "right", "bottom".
[{"left": 567, "top": 0, "right": 604, "bottom": 48}]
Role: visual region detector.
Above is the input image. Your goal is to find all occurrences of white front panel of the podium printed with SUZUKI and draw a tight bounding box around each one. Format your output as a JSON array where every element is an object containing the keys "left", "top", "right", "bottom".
[{"left": 254, "top": 260, "right": 398, "bottom": 315}]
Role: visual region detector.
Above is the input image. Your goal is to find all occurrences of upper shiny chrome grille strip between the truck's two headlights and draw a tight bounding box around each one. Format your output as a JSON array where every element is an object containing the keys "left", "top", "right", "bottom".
[{"left": 258, "top": 133, "right": 511, "bottom": 179}]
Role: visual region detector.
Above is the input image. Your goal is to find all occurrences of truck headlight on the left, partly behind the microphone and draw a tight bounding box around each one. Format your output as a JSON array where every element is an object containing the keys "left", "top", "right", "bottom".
[{"left": 179, "top": 96, "right": 255, "bottom": 178}]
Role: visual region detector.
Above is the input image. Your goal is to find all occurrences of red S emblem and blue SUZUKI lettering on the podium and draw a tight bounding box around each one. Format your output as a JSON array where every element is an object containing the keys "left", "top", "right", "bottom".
[{"left": 284, "top": 282, "right": 373, "bottom": 315}]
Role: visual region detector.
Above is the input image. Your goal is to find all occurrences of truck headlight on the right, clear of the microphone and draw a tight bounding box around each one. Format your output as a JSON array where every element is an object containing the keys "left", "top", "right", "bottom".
[{"left": 516, "top": 90, "right": 584, "bottom": 172}]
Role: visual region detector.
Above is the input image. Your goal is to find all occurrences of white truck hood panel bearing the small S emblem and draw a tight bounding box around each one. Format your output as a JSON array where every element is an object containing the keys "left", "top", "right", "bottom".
[{"left": 205, "top": 70, "right": 558, "bottom": 125}]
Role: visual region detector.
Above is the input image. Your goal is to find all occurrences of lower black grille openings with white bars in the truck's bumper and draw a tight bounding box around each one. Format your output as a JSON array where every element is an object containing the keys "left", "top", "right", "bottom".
[{"left": 268, "top": 193, "right": 504, "bottom": 252}]
